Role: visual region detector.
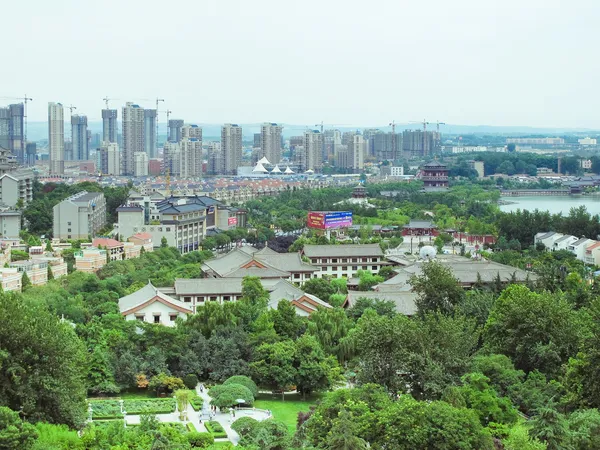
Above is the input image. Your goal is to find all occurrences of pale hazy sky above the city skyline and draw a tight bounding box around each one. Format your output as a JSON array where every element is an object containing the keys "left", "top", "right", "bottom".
[{"left": 0, "top": 0, "right": 600, "bottom": 128}]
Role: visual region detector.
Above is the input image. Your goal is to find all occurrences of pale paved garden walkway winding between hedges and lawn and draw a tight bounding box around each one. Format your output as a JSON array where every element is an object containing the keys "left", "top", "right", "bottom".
[{"left": 116, "top": 385, "right": 269, "bottom": 445}]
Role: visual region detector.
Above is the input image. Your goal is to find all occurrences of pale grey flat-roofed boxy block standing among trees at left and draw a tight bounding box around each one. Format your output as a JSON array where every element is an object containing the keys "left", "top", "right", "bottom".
[{"left": 53, "top": 191, "right": 106, "bottom": 239}]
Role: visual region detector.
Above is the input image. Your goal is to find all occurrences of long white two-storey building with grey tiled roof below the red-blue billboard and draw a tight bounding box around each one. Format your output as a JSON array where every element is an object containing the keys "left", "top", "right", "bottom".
[{"left": 302, "top": 244, "right": 387, "bottom": 278}]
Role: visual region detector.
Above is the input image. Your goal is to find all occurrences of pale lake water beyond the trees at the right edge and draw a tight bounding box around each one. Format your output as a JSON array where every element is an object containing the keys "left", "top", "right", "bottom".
[{"left": 500, "top": 196, "right": 600, "bottom": 215}]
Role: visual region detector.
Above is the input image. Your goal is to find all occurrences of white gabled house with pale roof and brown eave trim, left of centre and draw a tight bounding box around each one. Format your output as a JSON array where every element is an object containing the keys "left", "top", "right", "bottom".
[{"left": 119, "top": 283, "right": 192, "bottom": 327}]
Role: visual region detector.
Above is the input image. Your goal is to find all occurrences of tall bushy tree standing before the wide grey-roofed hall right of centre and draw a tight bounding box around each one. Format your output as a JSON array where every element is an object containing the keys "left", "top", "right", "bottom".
[{"left": 409, "top": 260, "right": 464, "bottom": 316}]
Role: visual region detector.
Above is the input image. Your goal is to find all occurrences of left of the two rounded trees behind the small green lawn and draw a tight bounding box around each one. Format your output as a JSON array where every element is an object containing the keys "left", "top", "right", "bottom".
[{"left": 250, "top": 340, "right": 297, "bottom": 400}]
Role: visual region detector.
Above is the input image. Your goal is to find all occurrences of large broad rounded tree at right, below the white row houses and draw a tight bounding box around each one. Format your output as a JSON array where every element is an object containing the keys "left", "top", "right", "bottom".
[{"left": 484, "top": 285, "right": 578, "bottom": 375}]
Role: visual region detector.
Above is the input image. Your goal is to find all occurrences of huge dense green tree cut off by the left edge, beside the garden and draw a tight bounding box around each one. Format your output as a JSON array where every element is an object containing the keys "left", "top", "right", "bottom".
[{"left": 0, "top": 294, "right": 86, "bottom": 426}]
